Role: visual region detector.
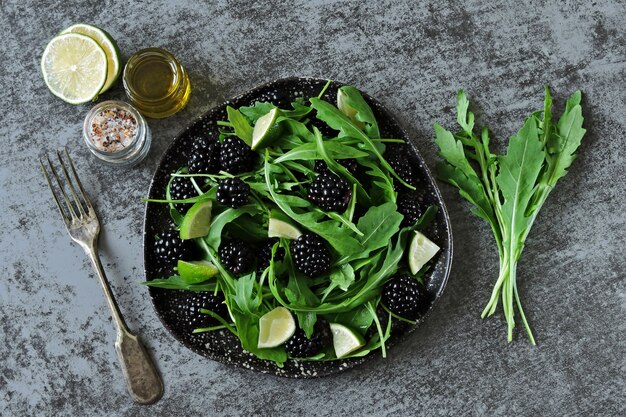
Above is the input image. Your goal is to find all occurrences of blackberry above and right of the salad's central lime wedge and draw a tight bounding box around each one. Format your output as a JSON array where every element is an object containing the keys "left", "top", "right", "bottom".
[{"left": 307, "top": 171, "right": 352, "bottom": 211}]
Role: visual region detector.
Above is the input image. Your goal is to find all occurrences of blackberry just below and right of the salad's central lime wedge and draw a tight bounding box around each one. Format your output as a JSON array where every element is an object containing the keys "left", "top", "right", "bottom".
[{"left": 291, "top": 233, "right": 330, "bottom": 278}]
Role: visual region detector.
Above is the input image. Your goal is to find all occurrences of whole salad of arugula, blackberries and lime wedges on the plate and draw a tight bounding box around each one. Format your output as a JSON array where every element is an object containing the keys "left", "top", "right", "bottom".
[{"left": 146, "top": 82, "right": 439, "bottom": 366}]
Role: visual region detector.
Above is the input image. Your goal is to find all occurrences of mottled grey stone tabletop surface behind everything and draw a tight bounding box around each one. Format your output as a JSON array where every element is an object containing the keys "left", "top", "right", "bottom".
[{"left": 0, "top": 0, "right": 626, "bottom": 416}]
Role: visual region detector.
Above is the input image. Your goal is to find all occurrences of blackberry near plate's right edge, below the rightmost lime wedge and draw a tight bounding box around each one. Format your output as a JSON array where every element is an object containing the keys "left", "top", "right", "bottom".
[{"left": 381, "top": 275, "right": 428, "bottom": 320}]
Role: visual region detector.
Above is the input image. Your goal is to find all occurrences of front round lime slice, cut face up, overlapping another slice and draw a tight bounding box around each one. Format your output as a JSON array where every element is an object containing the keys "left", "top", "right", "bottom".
[{"left": 41, "top": 33, "right": 107, "bottom": 104}]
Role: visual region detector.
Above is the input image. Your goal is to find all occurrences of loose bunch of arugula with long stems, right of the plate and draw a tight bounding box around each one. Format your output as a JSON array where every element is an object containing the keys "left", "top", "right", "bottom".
[{"left": 434, "top": 86, "right": 585, "bottom": 345}]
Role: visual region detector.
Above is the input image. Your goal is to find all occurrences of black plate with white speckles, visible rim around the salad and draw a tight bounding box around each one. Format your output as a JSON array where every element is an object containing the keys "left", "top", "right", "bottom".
[{"left": 144, "top": 78, "right": 452, "bottom": 378}]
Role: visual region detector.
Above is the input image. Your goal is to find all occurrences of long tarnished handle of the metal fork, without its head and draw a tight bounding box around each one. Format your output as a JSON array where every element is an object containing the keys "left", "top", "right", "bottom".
[{"left": 85, "top": 244, "right": 163, "bottom": 404}]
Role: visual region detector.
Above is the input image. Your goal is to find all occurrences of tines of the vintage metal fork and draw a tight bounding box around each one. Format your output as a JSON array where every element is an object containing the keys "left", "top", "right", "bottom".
[{"left": 39, "top": 148, "right": 93, "bottom": 222}]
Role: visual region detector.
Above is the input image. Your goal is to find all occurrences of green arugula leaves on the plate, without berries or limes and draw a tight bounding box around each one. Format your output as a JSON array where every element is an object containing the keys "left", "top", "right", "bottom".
[{"left": 146, "top": 82, "right": 437, "bottom": 366}]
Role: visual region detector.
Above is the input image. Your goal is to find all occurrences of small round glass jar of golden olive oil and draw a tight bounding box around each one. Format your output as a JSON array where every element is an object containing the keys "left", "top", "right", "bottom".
[{"left": 122, "top": 48, "right": 191, "bottom": 119}]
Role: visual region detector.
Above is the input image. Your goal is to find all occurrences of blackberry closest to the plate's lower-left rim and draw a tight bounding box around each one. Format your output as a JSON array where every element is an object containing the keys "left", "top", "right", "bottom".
[{"left": 176, "top": 291, "right": 228, "bottom": 332}]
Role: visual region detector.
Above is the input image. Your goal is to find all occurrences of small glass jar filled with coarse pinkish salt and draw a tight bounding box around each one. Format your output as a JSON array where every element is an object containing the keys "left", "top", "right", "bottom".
[{"left": 83, "top": 100, "right": 152, "bottom": 167}]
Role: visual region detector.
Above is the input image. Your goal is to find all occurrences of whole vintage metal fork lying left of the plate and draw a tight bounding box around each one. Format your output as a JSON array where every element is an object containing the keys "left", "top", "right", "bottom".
[{"left": 39, "top": 148, "right": 163, "bottom": 404}]
